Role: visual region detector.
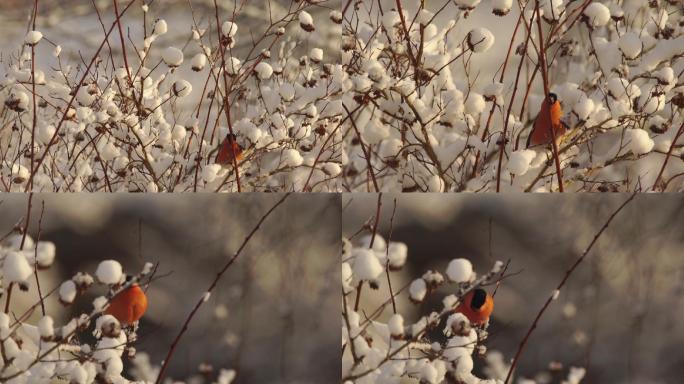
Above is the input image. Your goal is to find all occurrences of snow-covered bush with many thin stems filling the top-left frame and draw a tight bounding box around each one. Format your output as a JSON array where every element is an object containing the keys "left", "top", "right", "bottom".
[{"left": 0, "top": 1, "right": 345, "bottom": 192}]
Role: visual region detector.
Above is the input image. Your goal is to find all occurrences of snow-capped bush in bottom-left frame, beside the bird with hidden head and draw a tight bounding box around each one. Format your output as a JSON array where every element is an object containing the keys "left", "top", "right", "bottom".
[{"left": 0, "top": 233, "right": 162, "bottom": 384}]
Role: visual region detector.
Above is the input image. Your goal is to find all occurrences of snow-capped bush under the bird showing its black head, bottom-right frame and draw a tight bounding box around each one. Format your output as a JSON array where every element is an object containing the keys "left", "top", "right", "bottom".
[{"left": 342, "top": 230, "right": 510, "bottom": 383}]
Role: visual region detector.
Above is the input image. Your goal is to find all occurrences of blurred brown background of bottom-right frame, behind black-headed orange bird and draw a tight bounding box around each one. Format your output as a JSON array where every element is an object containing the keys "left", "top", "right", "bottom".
[{"left": 343, "top": 194, "right": 684, "bottom": 383}]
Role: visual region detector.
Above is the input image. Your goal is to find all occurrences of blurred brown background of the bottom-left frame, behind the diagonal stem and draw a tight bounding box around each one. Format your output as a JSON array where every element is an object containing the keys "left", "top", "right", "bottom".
[{"left": 0, "top": 194, "right": 341, "bottom": 383}]
